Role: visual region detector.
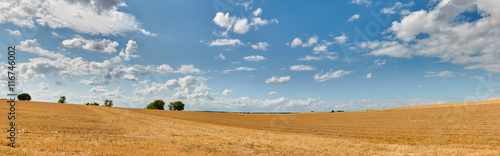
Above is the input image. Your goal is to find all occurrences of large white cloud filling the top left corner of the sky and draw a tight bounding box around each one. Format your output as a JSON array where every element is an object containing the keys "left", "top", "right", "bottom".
[{"left": 0, "top": 0, "right": 151, "bottom": 35}]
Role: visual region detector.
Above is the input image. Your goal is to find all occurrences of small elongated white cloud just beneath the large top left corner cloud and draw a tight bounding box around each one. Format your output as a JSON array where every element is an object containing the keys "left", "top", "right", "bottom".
[{"left": 61, "top": 36, "right": 119, "bottom": 53}]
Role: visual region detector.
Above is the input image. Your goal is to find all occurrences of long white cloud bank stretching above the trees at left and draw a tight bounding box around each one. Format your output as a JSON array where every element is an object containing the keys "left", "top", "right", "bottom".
[{"left": 18, "top": 42, "right": 203, "bottom": 85}]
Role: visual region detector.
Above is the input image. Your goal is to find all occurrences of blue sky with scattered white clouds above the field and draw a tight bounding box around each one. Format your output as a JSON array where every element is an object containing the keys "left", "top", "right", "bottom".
[{"left": 0, "top": 0, "right": 500, "bottom": 111}]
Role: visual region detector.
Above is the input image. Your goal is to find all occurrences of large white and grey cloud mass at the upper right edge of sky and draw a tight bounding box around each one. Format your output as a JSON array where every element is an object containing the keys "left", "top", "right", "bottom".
[{"left": 362, "top": 0, "right": 500, "bottom": 72}]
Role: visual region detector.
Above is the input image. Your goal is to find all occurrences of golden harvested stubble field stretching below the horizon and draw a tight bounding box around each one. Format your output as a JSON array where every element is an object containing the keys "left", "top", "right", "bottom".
[{"left": 0, "top": 99, "right": 500, "bottom": 155}]
